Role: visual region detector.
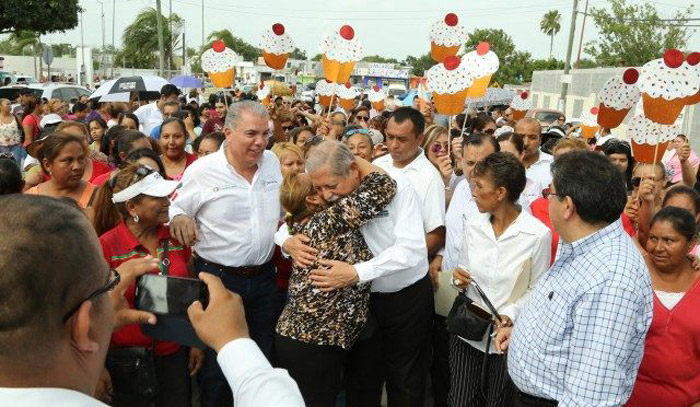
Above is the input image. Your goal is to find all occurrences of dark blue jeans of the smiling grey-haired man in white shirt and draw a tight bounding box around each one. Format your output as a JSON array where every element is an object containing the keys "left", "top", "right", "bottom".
[{"left": 194, "top": 258, "right": 279, "bottom": 407}]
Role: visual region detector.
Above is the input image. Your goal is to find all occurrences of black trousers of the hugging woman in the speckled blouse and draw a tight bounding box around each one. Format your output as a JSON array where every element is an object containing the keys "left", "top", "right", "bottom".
[{"left": 275, "top": 334, "right": 348, "bottom": 407}]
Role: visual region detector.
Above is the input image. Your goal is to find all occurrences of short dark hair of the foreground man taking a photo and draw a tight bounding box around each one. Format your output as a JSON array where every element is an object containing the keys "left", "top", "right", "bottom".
[{"left": 0, "top": 194, "right": 107, "bottom": 372}]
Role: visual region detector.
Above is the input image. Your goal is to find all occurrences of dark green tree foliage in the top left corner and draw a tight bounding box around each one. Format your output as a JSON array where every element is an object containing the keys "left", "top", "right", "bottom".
[{"left": 0, "top": 0, "right": 81, "bottom": 35}]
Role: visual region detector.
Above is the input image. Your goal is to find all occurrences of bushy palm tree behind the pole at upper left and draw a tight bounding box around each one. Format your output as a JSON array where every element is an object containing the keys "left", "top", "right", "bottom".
[{"left": 115, "top": 8, "right": 183, "bottom": 68}]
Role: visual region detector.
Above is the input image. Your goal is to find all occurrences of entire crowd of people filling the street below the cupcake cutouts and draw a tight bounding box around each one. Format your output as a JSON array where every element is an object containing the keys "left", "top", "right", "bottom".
[{"left": 0, "top": 79, "right": 700, "bottom": 407}]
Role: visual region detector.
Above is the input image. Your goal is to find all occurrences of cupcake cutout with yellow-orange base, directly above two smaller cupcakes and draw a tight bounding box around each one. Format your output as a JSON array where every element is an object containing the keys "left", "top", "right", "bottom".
[{"left": 320, "top": 25, "right": 364, "bottom": 83}]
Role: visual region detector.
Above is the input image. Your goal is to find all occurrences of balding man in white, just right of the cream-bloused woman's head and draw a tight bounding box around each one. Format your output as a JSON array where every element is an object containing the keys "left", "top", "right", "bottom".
[{"left": 515, "top": 117, "right": 554, "bottom": 188}]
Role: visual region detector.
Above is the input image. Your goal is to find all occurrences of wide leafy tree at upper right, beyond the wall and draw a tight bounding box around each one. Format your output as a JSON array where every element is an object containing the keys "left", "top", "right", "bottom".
[{"left": 585, "top": 0, "right": 695, "bottom": 66}]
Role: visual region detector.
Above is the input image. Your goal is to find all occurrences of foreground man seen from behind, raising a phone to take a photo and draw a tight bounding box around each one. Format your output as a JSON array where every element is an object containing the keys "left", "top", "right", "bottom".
[{"left": 0, "top": 195, "right": 304, "bottom": 407}]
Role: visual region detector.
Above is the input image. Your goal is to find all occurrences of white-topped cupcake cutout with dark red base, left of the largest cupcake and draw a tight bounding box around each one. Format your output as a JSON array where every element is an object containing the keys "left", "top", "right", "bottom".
[{"left": 598, "top": 68, "right": 641, "bottom": 129}]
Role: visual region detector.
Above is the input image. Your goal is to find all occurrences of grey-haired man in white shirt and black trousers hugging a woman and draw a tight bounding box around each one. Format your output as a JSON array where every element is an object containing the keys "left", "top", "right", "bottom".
[{"left": 282, "top": 141, "right": 433, "bottom": 407}]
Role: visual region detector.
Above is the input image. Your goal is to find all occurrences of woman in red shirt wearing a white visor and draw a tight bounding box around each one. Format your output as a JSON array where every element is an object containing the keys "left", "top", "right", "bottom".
[{"left": 98, "top": 164, "right": 204, "bottom": 407}]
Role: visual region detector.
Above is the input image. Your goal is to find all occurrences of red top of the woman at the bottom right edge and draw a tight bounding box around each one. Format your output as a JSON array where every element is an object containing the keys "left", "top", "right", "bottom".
[{"left": 625, "top": 279, "right": 700, "bottom": 407}]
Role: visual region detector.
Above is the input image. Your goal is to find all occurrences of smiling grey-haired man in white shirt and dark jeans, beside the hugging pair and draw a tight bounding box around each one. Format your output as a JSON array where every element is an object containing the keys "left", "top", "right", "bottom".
[{"left": 170, "top": 101, "right": 282, "bottom": 407}]
